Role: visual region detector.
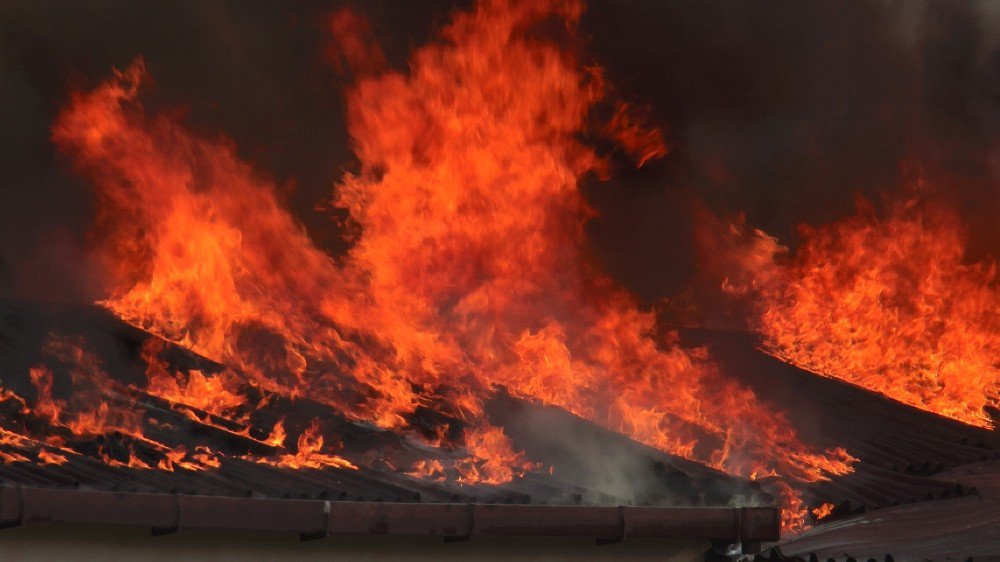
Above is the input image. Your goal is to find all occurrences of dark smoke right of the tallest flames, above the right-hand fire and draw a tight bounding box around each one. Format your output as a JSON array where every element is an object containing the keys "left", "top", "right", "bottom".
[{"left": 588, "top": 0, "right": 1000, "bottom": 302}]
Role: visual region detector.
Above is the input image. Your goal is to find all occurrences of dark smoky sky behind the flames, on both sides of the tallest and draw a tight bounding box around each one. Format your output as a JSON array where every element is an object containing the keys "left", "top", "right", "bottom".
[{"left": 0, "top": 0, "right": 1000, "bottom": 302}]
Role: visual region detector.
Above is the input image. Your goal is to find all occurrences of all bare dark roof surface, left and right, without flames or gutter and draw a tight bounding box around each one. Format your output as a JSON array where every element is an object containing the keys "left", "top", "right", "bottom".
[{"left": 0, "top": 303, "right": 1000, "bottom": 560}]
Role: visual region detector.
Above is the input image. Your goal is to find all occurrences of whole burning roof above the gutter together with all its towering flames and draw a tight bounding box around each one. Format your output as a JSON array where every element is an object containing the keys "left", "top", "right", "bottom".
[{"left": 0, "top": 0, "right": 1000, "bottom": 552}]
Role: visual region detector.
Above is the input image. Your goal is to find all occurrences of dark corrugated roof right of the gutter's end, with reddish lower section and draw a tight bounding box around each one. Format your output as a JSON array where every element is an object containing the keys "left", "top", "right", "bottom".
[{"left": 682, "top": 329, "right": 1000, "bottom": 562}]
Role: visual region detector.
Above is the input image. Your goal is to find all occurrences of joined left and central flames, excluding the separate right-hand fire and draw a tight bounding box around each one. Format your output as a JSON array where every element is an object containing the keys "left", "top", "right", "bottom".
[{"left": 53, "top": 0, "right": 853, "bottom": 528}]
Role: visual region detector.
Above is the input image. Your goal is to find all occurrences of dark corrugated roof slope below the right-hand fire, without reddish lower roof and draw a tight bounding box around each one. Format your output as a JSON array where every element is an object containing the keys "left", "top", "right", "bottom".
[{"left": 681, "top": 329, "right": 1000, "bottom": 520}]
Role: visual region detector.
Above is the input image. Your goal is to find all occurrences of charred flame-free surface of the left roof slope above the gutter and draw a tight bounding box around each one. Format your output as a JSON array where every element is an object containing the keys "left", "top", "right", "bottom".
[{"left": 0, "top": 302, "right": 771, "bottom": 506}]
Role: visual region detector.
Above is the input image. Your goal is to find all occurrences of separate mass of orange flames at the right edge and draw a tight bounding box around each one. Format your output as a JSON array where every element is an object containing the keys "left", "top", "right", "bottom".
[{"left": 758, "top": 202, "right": 1000, "bottom": 427}]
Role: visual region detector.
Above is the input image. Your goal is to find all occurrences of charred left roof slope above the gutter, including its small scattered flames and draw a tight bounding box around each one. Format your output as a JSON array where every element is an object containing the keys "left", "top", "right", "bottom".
[{"left": 0, "top": 303, "right": 770, "bottom": 506}]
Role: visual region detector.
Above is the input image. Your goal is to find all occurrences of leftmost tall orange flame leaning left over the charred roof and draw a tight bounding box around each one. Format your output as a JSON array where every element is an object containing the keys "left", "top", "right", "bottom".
[{"left": 53, "top": 55, "right": 417, "bottom": 426}]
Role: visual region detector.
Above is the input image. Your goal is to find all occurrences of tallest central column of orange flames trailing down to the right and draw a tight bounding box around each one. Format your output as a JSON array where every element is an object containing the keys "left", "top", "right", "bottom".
[{"left": 335, "top": 2, "right": 849, "bottom": 498}]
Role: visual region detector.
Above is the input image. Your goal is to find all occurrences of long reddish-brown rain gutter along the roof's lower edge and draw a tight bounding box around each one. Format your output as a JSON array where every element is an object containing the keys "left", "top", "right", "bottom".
[{"left": 0, "top": 486, "right": 781, "bottom": 543}]
